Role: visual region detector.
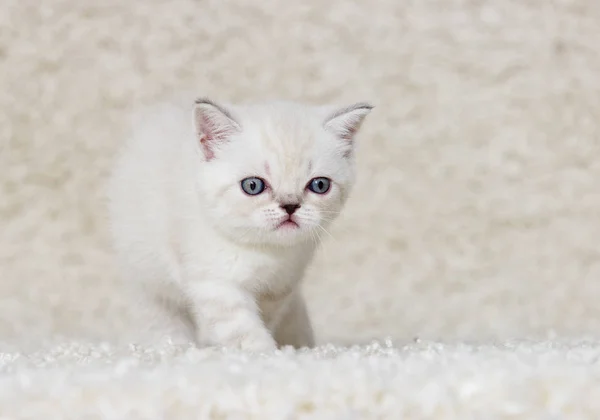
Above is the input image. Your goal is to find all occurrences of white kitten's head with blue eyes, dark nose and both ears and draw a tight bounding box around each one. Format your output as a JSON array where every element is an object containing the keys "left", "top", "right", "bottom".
[{"left": 194, "top": 99, "right": 372, "bottom": 246}]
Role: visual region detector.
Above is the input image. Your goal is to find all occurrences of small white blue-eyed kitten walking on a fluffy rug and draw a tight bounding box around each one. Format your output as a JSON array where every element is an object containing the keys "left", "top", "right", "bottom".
[{"left": 108, "top": 99, "right": 372, "bottom": 351}]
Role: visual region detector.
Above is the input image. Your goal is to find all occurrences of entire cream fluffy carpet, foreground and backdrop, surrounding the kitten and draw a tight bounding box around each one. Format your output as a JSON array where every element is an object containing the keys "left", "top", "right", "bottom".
[{"left": 0, "top": 0, "right": 600, "bottom": 419}]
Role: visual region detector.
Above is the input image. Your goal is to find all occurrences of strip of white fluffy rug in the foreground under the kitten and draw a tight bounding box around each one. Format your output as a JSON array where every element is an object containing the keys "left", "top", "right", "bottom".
[{"left": 0, "top": 341, "right": 600, "bottom": 420}]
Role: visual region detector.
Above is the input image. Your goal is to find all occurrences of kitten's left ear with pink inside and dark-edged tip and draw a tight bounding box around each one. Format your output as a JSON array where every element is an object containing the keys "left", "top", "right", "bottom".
[{"left": 194, "top": 98, "right": 241, "bottom": 160}]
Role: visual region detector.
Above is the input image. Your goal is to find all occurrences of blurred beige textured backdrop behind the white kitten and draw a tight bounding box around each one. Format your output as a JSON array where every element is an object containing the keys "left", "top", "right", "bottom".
[{"left": 0, "top": 0, "right": 600, "bottom": 346}]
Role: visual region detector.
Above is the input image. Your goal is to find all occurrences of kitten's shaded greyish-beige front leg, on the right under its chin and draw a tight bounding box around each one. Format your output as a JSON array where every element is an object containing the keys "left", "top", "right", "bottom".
[{"left": 274, "top": 291, "right": 315, "bottom": 348}]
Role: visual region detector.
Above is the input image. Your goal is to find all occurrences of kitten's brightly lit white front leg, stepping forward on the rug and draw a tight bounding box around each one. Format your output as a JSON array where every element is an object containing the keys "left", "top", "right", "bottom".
[{"left": 189, "top": 282, "right": 277, "bottom": 351}]
